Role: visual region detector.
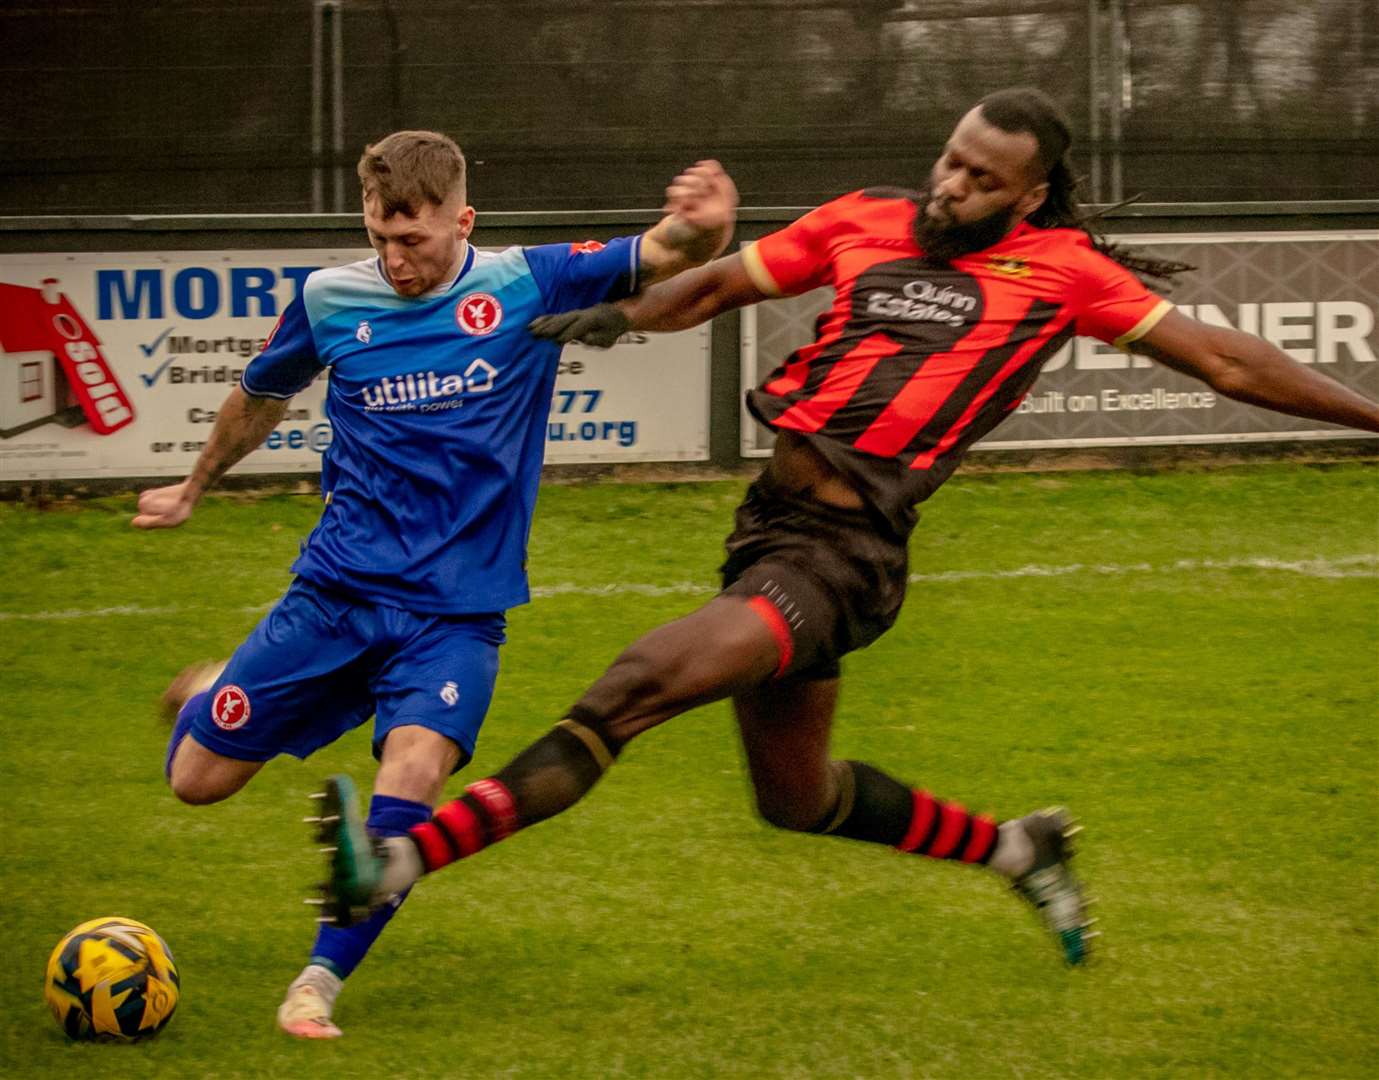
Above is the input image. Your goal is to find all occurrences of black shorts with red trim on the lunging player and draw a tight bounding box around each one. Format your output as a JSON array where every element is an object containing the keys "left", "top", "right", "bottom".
[{"left": 721, "top": 476, "right": 909, "bottom": 679}]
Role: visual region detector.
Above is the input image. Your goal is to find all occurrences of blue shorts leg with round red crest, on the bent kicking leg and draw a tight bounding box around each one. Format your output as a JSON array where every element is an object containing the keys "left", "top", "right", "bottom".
[{"left": 190, "top": 581, "right": 374, "bottom": 763}]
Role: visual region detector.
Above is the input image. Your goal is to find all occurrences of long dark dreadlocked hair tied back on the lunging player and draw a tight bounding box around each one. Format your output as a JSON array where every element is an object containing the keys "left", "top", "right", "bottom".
[{"left": 978, "top": 87, "right": 1197, "bottom": 286}]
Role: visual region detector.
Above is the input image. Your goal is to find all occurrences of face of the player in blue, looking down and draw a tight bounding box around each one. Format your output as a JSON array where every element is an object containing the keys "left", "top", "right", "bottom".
[{"left": 364, "top": 197, "right": 474, "bottom": 297}]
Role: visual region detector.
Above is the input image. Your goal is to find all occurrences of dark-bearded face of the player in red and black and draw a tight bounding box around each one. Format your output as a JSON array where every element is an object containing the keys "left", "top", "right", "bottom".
[{"left": 916, "top": 109, "right": 1048, "bottom": 258}]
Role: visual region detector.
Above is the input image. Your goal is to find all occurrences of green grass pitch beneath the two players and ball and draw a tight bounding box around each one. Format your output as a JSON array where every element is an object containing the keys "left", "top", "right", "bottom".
[{"left": 0, "top": 463, "right": 1379, "bottom": 1080}]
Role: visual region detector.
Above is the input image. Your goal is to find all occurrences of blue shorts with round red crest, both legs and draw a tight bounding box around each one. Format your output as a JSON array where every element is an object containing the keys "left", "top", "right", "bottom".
[{"left": 190, "top": 578, "right": 506, "bottom": 764}]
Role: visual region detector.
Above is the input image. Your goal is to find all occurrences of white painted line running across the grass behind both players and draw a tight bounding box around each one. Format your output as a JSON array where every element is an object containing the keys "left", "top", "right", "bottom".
[{"left": 0, "top": 554, "right": 1379, "bottom": 622}]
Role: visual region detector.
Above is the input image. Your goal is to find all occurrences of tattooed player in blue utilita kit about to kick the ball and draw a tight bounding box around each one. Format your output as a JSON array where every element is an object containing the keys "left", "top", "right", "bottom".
[{"left": 132, "top": 131, "right": 736, "bottom": 1039}]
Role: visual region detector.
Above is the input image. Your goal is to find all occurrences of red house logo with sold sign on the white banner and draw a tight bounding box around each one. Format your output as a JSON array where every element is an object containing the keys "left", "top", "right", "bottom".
[{"left": 0, "top": 277, "right": 134, "bottom": 439}]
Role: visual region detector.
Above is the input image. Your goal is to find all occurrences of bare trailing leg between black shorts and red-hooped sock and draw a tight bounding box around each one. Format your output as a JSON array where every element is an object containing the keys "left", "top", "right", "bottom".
[{"left": 732, "top": 679, "right": 838, "bottom": 828}]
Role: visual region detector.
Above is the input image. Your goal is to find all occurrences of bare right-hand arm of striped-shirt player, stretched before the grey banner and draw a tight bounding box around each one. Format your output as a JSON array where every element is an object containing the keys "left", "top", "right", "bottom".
[{"left": 1131, "top": 310, "right": 1379, "bottom": 432}]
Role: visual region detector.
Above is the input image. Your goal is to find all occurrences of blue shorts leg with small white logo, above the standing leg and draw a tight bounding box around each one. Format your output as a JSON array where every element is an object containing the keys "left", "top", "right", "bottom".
[{"left": 370, "top": 615, "right": 506, "bottom": 781}]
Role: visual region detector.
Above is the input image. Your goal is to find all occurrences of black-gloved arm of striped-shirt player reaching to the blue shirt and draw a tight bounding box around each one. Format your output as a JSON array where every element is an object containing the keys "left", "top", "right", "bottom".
[{"left": 530, "top": 254, "right": 769, "bottom": 349}]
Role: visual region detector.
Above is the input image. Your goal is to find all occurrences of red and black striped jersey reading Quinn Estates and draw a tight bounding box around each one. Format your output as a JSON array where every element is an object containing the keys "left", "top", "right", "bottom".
[{"left": 743, "top": 188, "right": 1171, "bottom": 535}]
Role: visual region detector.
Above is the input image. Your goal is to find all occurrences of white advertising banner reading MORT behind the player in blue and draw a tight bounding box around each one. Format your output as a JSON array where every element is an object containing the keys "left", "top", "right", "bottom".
[{"left": 0, "top": 248, "right": 709, "bottom": 480}]
